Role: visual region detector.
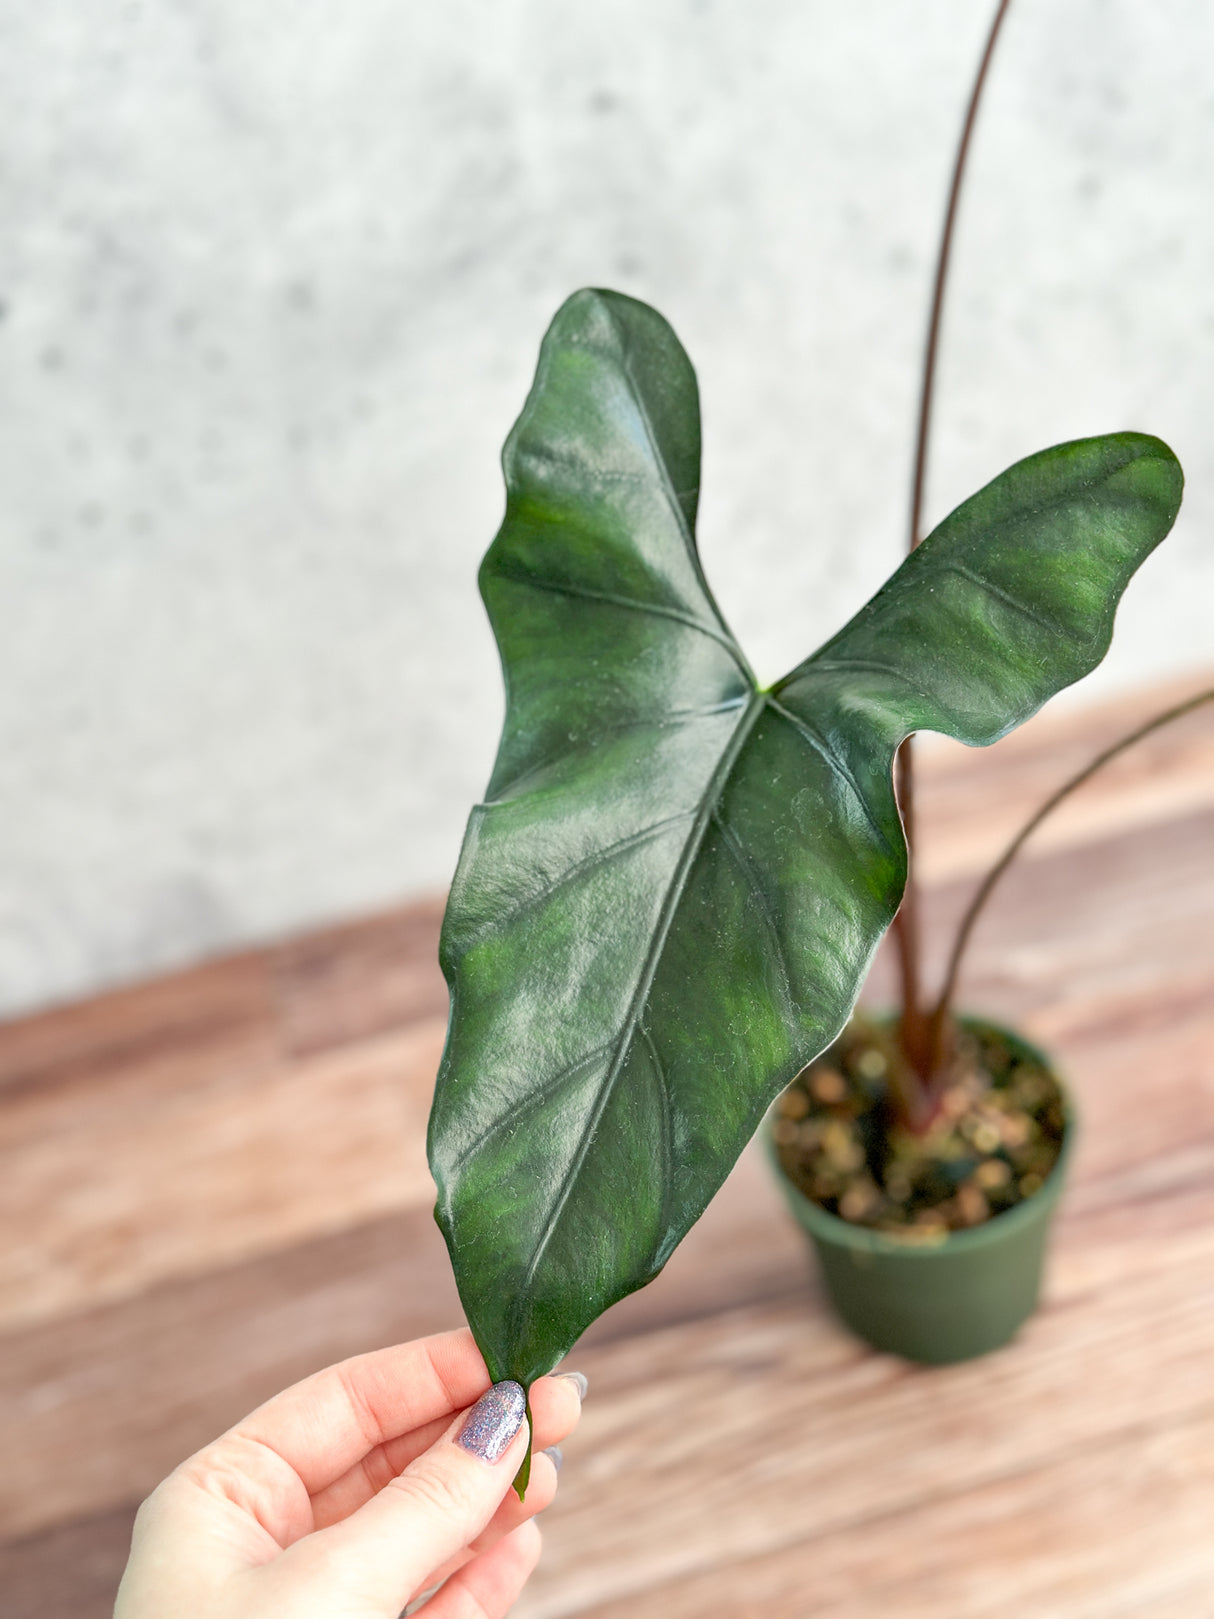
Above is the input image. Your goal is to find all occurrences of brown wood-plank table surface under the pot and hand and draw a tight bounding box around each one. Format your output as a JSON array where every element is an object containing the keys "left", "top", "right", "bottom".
[{"left": 0, "top": 678, "right": 1214, "bottom": 1619}]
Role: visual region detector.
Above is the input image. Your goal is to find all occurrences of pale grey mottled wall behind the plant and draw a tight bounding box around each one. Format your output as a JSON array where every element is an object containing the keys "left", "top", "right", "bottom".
[{"left": 0, "top": 0, "right": 1214, "bottom": 1013}]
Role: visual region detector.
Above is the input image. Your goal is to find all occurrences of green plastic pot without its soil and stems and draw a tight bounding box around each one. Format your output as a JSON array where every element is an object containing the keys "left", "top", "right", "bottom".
[{"left": 764, "top": 1018, "right": 1075, "bottom": 1366}]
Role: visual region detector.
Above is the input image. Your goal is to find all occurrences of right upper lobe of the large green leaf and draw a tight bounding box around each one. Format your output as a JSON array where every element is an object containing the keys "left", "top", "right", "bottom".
[{"left": 775, "top": 432, "right": 1183, "bottom": 746}]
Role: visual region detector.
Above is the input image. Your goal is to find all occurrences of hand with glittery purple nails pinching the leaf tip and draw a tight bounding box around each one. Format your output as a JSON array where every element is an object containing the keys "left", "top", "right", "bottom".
[{"left": 113, "top": 1331, "right": 584, "bottom": 1619}]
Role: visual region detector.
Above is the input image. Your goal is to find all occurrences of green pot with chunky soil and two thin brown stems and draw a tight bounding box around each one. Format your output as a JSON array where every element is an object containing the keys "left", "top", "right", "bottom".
[{"left": 769, "top": 0, "right": 1214, "bottom": 1362}]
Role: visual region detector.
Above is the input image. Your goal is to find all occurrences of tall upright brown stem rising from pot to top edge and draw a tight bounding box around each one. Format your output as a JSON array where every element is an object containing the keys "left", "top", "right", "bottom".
[{"left": 894, "top": 0, "right": 1010, "bottom": 1087}]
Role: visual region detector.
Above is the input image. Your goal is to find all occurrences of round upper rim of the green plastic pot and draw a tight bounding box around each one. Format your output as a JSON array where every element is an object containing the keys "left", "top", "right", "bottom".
[{"left": 762, "top": 1013, "right": 1076, "bottom": 1263}]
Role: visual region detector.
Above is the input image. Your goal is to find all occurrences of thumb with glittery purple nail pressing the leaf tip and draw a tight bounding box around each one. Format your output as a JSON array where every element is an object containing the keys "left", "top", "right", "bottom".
[{"left": 272, "top": 1383, "right": 528, "bottom": 1614}]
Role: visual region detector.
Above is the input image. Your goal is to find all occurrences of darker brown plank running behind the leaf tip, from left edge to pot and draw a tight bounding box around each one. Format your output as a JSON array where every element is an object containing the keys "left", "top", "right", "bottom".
[{"left": 0, "top": 1154, "right": 808, "bottom": 1538}]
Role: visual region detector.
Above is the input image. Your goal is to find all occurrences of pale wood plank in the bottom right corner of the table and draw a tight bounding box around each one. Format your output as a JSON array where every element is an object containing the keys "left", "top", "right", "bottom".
[{"left": 563, "top": 1413, "right": 1214, "bottom": 1619}]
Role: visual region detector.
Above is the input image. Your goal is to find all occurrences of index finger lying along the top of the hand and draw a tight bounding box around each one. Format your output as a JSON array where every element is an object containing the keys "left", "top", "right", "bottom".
[{"left": 228, "top": 1328, "right": 490, "bottom": 1496}]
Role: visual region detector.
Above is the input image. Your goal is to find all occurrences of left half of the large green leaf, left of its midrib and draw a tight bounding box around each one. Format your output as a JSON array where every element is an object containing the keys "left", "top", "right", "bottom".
[{"left": 431, "top": 293, "right": 758, "bottom": 1383}]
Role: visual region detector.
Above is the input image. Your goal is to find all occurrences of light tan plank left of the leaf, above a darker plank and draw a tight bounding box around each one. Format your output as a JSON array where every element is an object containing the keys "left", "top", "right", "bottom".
[{"left": 0, "top": 1020, "right": 444, "bottom": 1324}]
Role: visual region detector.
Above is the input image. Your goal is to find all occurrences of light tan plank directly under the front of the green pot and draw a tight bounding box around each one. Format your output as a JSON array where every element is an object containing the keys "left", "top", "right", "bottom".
[{"left": 518, "top": 1232, "right": 1214, "bottom": 1619}]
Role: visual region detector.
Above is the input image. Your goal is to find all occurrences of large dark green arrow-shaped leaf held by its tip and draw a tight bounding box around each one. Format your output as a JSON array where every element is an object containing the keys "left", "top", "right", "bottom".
[{"left": 431, "top": 291, "right": 1182, "bottom": 1384}]
